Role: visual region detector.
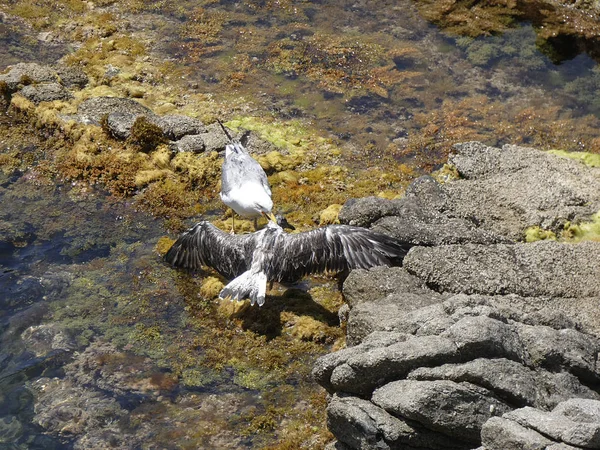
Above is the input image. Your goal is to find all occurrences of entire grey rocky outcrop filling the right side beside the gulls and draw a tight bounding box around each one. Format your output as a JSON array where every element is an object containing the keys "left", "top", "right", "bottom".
[{"left": 313, "top": 142, "right": 600, "bottom": 449}]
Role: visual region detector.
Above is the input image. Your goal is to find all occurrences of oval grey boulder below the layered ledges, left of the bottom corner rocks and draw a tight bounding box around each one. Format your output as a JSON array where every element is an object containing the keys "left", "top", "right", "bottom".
[{"left": 371, "top": 380, "right": 511, "bottom": 443}]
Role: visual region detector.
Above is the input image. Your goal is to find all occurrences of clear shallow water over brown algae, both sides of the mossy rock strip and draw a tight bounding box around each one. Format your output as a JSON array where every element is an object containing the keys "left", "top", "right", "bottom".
[{"left": 0, "top": 1, "right": 600, "bottom": 449}]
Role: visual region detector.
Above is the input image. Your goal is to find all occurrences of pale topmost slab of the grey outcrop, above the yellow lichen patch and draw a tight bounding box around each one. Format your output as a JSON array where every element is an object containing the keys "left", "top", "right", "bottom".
[{"left": 445, "top": 142, "right": 600, "bottom": 239}]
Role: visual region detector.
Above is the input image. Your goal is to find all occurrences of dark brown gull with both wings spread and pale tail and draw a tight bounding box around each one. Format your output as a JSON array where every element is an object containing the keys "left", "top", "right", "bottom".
[{"left": 165, "top": 221, "right": 410, "bottom": 306}]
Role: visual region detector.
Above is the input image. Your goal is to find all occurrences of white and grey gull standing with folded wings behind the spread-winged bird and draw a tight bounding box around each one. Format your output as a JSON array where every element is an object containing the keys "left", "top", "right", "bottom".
[{"left": 218, "top": 120, "right": 276, "bottom": 234}]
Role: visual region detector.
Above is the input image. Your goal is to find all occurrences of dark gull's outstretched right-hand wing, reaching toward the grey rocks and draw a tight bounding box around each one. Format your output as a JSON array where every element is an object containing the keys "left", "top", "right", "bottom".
[{"left": 266, "top": 225, "right": 411, "bottom": 281}]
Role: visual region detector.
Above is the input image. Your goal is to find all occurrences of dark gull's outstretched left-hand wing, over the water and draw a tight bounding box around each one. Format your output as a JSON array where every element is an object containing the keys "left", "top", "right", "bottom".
[{"left": 165, "top": 221, "right": 256, "bottom": 278}]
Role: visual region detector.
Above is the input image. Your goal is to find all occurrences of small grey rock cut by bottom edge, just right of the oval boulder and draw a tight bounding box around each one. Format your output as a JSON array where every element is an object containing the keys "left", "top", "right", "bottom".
[{"left": 481, "top": 417, "right": 554, "bottom": 450}]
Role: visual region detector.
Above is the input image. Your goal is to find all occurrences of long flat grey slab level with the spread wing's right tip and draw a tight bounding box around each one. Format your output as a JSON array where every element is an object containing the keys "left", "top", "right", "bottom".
[{"left": 403, "top": 241, "right": 600, "bottom": 298}]
